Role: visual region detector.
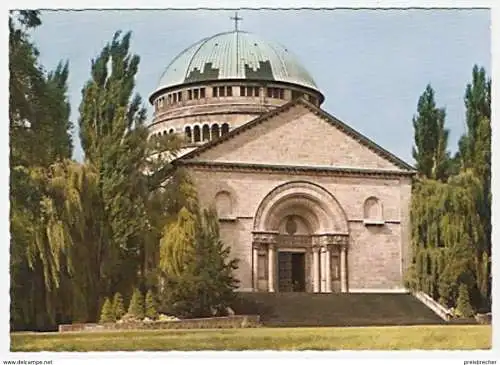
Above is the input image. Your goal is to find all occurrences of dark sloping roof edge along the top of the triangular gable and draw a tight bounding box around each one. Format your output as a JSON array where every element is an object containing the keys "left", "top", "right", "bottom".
[{"left": 177, "top": 97, "right": 416, "bottom": 171}]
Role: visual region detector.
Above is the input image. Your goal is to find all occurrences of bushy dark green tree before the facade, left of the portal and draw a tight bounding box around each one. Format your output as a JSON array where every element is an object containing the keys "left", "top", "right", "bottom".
[{"left": 161, "top": 206, "right": 237, "bottom": 317}]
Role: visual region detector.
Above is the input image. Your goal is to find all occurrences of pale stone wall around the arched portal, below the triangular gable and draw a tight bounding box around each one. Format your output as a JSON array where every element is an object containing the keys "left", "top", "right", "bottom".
[{"left": 188, "top": 161, "right": 410, "bottom": 291}]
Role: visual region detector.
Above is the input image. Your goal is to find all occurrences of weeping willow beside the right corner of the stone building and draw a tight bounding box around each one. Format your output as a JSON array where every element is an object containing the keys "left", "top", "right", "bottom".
[{"left": 411, "top": 171, "right": 487, "bottom": 306}]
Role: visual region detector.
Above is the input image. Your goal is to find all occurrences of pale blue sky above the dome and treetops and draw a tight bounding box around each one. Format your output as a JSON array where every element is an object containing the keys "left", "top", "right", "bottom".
[{"left": 32, "top": 9, "right": 491, "bottom": 163}]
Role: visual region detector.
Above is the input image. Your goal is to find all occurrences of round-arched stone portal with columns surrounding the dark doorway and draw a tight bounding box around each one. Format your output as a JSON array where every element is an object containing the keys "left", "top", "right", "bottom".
[{"left": 252, "top": 181, "right": 349, "bottom": 293}]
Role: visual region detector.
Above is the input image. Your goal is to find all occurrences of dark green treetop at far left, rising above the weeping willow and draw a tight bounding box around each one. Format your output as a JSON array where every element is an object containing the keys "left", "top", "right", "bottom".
[{"left": 9, "top": 11, "right": 72, "bottom": 166}]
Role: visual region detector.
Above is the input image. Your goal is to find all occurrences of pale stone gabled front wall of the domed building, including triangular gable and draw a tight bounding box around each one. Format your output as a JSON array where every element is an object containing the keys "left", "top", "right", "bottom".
[{"left": 172, "top": 102, "right": 412, "bottom": 292}]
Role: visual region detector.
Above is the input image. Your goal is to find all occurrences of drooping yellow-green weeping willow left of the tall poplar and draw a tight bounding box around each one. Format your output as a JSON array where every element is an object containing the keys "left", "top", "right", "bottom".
[{"left": 28, "top": 160, "right": 102, "bottom": 322}]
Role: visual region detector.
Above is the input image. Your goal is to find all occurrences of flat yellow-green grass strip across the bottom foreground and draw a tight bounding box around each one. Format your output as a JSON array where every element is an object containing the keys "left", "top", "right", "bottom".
[{"left": 11, "top": 325, "right": 491, "bottom": 351}]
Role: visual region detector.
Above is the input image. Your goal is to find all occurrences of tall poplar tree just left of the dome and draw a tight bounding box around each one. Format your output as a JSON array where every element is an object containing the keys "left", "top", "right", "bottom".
[{"left": 79, "top": 32, "right": 147, "bottom": 295}]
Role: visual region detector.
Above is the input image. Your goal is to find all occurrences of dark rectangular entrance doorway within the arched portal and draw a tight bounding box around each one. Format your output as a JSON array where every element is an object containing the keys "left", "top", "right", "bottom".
[{"left": 278, "top": 252, "right": 306, "bottom": 292}]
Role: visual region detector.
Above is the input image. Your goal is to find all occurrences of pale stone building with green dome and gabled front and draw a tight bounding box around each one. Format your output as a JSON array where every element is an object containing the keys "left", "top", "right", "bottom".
[{"left": 149, "top": 21, "right": 415, "bottom": 293}]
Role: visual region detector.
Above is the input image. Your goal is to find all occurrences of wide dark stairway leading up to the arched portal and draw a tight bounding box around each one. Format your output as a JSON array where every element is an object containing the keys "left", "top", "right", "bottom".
[{"left": 233, "top": 292, "right": 446, "bottom": 327}]
